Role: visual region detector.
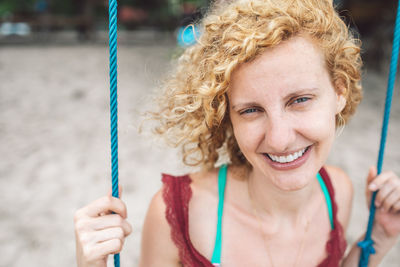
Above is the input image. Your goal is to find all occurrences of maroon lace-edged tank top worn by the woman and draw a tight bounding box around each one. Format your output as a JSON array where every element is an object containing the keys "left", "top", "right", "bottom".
[{"left": 162, "top": 168, "right": 347, "bottom": 267}]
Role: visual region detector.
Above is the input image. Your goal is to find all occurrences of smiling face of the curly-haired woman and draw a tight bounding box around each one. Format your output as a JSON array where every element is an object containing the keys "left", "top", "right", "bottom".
[{"left": 228, "top": 37, "right": 345, "bottom": 190}]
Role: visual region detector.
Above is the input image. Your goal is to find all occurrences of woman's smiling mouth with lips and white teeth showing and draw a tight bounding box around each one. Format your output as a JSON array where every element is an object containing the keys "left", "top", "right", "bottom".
[{"left": 263, "top": 145, "right": 312, "bottom": 170}]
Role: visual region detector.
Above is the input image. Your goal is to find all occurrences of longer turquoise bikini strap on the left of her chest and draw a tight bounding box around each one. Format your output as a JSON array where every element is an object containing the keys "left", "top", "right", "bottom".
[{"left": 211, "top": 165, "right": 228, "bottom": 264}]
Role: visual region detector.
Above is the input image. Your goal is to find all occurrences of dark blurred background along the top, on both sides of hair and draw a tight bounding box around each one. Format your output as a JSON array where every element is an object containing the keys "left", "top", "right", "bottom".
[{"left": 0, "top": 0, "right": 396, "bottom": 66}]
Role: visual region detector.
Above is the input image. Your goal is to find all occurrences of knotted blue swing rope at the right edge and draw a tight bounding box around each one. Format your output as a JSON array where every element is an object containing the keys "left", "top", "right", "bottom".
[{"left": 358, "top": 0, "right": 400, "bottom": 267}]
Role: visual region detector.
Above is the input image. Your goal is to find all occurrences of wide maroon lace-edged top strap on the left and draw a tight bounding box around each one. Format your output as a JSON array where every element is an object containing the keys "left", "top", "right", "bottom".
[{"left": 162, "top": 174, "right": 213, "bottom": 267}]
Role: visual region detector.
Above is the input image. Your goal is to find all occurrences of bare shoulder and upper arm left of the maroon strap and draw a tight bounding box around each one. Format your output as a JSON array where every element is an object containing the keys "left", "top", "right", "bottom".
[{"left": 139, "top": 189, "right": 180, "bottom": 267}]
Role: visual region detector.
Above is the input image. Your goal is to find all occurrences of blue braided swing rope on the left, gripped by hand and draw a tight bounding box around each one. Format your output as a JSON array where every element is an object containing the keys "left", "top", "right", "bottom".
[{"left": 108, "top": 0, "right": 120, "bottom": 267}]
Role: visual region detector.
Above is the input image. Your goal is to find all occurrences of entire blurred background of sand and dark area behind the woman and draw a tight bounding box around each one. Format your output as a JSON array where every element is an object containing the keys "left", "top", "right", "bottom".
[{"left": 0, "top": 0, "right": 400, "bottom": 267}]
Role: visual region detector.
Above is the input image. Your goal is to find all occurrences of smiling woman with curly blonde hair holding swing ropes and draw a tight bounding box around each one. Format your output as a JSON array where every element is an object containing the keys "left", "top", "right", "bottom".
[{"left": 75, "top": 0, "right": 400, "bottom": 267}]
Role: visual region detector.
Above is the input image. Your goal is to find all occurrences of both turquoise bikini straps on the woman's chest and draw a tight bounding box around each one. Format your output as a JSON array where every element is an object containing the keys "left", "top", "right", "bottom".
[{"left": 211, "top": 164, "right": 334, "bottom": 265}]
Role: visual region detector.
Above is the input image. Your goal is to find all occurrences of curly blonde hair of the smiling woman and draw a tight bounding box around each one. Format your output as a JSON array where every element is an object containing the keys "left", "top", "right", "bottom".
[{"left": 152, "top": 0, "right": 362, "bottom": 169}]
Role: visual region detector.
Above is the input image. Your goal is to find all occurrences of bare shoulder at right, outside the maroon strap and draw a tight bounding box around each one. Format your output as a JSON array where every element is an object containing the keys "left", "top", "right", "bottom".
[{"left": 325, "top": 165, "right": 354, "bottom": 230}]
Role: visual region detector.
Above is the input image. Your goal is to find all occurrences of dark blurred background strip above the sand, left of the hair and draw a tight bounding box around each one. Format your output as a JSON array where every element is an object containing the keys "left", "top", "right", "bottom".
[{"left": 0, "top": 0, "right": 209, "bottom": 43}]
